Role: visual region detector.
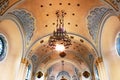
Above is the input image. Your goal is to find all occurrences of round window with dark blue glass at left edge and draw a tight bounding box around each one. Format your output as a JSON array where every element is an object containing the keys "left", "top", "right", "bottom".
[{"left": 0, "top": 34, "right": 7, "bottom": 61}]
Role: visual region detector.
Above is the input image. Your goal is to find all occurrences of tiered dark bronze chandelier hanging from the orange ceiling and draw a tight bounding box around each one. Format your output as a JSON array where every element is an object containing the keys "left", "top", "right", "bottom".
[{"left": 48, "top": 10, "right": 71, "bottom": 49}]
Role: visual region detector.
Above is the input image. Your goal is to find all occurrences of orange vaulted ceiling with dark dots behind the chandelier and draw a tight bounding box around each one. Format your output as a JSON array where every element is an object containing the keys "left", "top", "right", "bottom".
[{"left": 0, "top": 0, "right": 119, "bottom": 79}]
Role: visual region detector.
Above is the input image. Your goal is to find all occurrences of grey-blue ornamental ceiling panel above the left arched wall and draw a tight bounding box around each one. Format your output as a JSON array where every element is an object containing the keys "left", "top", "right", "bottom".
[{"left": 8, "top": 9, "right": 35, "bottom": 45}]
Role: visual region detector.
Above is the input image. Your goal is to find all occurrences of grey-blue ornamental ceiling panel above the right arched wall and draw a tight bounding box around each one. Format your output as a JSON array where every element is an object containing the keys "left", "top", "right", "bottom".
[{"left": 87, "top": 7, "right": 115, "bottom": 44}]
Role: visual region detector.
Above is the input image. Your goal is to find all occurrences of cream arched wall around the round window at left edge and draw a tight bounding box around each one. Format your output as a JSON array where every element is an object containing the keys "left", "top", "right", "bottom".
[{"left": 0, "top": 19, "right": 23, "bottom": 80}]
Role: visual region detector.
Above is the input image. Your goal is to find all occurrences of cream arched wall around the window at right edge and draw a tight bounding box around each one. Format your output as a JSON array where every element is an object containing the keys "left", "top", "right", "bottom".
[{"left": 100, "top": 16, "right": 120, "bottom": 80}]
